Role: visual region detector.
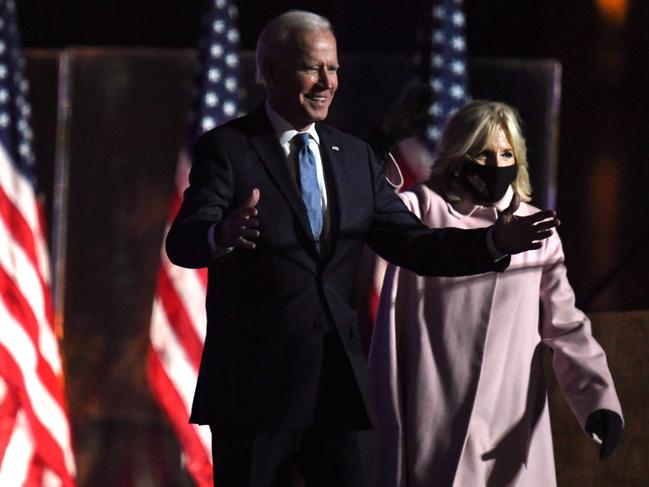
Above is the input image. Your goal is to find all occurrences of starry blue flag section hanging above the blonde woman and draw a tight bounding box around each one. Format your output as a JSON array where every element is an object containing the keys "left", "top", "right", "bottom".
[{"left": 419, "top": 0, "right": 469, "bottom": 150}]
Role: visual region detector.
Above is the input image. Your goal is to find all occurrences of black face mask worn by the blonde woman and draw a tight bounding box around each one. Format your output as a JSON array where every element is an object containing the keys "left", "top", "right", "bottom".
[{"left": 460, "top": 161, "right": 518, "bottom": 203}]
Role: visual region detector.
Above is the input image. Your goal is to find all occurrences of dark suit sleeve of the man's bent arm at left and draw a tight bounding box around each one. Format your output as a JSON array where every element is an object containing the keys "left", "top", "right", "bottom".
[{"left": 165, "top": 132, "right": 233, "bottom": 268}]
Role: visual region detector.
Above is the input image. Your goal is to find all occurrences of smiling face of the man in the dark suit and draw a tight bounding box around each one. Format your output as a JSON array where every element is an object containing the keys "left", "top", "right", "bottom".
[{"left": 265, "top": 30, "right": 338, "bottom": 130}]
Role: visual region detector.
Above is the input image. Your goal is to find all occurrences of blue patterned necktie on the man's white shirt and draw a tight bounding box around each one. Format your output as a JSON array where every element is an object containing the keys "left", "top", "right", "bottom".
[{"left": 294, "top": 132, "right": 322, "bottom": 241}]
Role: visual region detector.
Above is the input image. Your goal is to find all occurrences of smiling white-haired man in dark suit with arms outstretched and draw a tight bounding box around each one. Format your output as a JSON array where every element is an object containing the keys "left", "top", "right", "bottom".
[{"left": 166, "top": 11, "right": 557, "bottom": 487}]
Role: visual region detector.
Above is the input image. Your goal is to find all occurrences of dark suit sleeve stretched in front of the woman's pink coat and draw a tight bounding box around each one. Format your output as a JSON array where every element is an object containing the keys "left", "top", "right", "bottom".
[{"left": 368, "top": 143, "right": 509, "bottom": 276}]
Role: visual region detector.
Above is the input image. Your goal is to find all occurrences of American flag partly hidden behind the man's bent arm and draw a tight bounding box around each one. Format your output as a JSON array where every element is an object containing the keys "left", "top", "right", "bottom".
[{"left": 148, "top": 0, "right": 241, "bottom": 487}]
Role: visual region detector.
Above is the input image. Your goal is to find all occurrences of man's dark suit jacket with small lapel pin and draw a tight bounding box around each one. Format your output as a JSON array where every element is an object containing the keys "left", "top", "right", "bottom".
[{"left": 166, "top": 107, "right": 508, "bottom": 429}]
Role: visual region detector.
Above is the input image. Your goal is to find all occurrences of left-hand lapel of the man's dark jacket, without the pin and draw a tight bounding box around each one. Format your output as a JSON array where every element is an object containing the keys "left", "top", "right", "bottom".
[{"left": 250, "top": 107, "right": 318, "bottom": 256}]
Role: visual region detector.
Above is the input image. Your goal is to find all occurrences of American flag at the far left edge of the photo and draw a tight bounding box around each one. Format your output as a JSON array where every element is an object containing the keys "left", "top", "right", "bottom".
[{"left": 0, "top": 0, "right": 75, "bottom": 487}]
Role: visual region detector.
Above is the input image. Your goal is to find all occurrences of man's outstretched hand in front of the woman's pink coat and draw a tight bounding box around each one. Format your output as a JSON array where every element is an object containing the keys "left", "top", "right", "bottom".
[{"left": 492, "top": 193, "right": 560, "bottom": 255}]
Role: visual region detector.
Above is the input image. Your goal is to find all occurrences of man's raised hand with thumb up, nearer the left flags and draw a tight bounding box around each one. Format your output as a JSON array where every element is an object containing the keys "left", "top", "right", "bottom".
[{"left": 214, "top": 188, "right": 259, "bottom": 250}]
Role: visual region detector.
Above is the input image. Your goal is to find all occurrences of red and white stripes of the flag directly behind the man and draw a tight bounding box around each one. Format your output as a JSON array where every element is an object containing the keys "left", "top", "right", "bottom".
[{"left": 147, "top": 151, "right": 213, "bottom": 487}]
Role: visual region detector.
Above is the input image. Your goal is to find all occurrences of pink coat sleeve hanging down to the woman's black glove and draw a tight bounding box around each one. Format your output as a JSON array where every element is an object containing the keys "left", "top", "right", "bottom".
[{"left": 540, "top": 234, "right": 622, "bottom": 428}]
